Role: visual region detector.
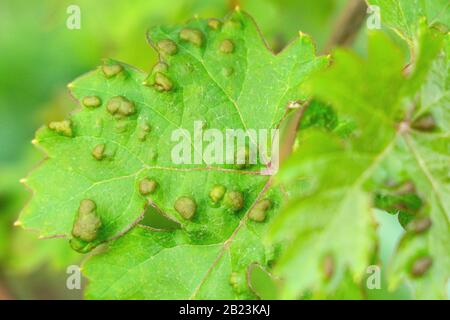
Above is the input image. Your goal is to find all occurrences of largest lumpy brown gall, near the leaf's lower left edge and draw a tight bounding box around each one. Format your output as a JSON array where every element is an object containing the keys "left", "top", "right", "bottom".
[{"left": 72, "top": 199, "right": 102, "bottom": 242}]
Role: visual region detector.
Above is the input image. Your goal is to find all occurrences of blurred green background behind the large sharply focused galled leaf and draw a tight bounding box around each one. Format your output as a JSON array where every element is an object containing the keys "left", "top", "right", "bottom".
[{"left": 0, "top": 0, "right": 408, "bottom": 299}]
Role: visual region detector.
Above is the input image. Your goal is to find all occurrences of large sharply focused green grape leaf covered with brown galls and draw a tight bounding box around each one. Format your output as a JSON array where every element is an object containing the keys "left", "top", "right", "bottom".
[{"left": 19, "top": 11, "right": 328, "bottom": 298}]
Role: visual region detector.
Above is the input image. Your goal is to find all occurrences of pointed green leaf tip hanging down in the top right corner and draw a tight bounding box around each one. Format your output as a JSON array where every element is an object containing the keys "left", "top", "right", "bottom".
[{"left": 368, "top": 0, "right": 450, "bottom": 46}]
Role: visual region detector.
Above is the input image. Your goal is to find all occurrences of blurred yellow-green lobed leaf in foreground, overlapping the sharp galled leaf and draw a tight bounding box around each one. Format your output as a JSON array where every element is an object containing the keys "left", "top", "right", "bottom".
[{"left": 270, "top": 26, "right": 449, "bottom": 298}]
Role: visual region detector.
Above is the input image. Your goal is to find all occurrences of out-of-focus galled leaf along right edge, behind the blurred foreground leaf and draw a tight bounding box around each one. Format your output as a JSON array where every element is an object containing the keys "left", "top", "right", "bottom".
[{"left": 389, "top": 36, "right": 450, "bottom": 299}]
